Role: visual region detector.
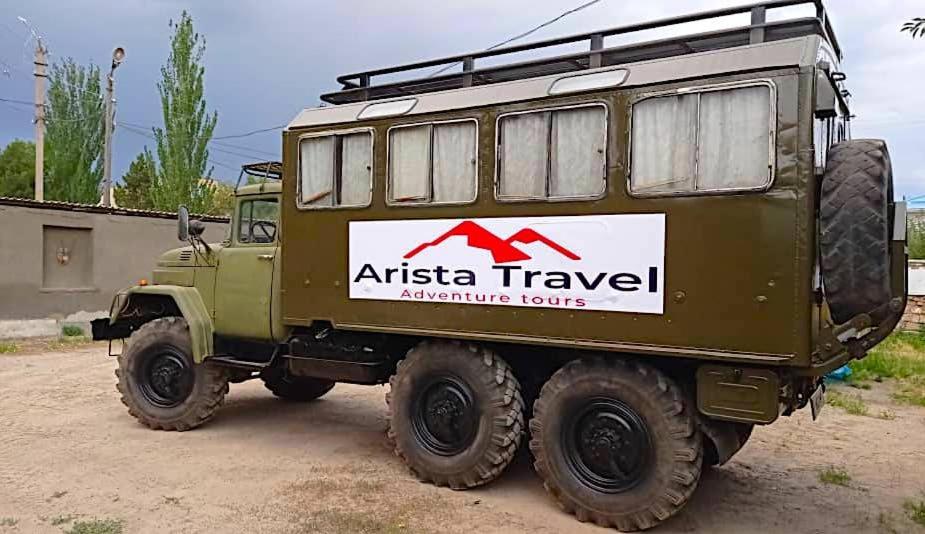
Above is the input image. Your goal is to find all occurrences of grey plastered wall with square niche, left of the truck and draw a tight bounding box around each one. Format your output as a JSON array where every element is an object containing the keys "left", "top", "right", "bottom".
[{"left": 0, "top": 199, "right": 228, "bottom": 338}]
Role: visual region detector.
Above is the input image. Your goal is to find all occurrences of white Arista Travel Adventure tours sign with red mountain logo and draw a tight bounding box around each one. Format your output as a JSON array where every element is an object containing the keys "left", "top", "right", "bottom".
[{"left": 350, "top": 214, "right": 665, "bottom": 314}]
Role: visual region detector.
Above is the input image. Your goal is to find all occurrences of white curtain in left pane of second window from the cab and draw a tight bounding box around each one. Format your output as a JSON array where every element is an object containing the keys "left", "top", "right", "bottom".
[{"left": 389, "top": 125, "right": 431, "bottom": 202}]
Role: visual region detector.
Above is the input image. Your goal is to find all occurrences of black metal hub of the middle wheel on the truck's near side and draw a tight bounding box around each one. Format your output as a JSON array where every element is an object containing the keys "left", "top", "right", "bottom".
[{"left": 412, "top": 376, "right": 478, "bottom": 456}]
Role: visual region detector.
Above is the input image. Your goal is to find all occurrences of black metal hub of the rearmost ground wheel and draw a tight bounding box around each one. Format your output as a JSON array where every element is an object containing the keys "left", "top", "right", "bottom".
[{"left": 562, "top": 398, "right": 651, "bottom": 493}]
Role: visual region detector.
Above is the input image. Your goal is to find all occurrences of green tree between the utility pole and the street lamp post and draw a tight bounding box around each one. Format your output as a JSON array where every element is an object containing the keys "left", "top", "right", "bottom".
[{"left": 45, "top": 58, "right": 103, "bottom": 204}]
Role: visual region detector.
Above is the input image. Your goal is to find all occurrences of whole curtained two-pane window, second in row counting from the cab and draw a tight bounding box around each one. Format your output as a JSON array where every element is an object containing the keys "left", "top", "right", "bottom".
[{"left": 389, "top": 120, "right": 478, "bottom": 204}]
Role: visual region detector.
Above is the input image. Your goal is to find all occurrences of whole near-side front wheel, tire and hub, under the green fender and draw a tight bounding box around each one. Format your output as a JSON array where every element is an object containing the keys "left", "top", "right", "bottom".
[{"left": 116, "top": 317, "right": 228, "bottom": 431}]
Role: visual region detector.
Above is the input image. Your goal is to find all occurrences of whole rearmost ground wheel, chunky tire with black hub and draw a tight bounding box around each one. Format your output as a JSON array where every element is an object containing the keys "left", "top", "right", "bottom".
[{"left": 530, "top": 360, "right": 703, "bottom": 531}]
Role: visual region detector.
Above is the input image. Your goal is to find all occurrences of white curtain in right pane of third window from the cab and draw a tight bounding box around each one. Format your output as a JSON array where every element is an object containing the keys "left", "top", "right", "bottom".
[{"left": 549, "top": 106, "right": 607, "bottom": 197}]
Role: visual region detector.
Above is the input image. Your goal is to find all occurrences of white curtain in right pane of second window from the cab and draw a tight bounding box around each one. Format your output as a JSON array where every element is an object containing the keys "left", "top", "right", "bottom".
[{"left": 433, "top": 122, "right": 477, "bottom": 202}]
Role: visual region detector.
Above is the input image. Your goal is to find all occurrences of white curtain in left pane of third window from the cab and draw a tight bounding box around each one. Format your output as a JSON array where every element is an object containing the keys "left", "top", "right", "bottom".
[{"left": 500, "top": 112, "right": 549, "bottom": 198}]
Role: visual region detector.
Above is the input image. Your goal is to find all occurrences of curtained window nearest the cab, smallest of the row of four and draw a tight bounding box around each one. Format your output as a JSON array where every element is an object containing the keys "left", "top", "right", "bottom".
[{"left": 299, "top": 131, "right": 373, "bottom": 208}]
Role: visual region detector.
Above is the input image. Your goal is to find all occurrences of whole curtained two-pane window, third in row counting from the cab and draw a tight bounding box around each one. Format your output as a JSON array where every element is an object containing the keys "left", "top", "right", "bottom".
[{"left": 497, "top": 104, "right": 607, "bottom": 200}]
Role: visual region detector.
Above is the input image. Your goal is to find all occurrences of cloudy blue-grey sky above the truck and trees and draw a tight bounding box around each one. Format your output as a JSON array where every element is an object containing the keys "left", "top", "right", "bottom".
[{"left": 0, "top": 0, "right": 925, "bottom": 202}]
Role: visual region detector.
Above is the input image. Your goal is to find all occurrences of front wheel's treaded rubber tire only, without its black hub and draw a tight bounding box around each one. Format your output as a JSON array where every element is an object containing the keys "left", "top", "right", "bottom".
[{"left": 116, "top": 317, "right": 228, "bottom": 431}]
